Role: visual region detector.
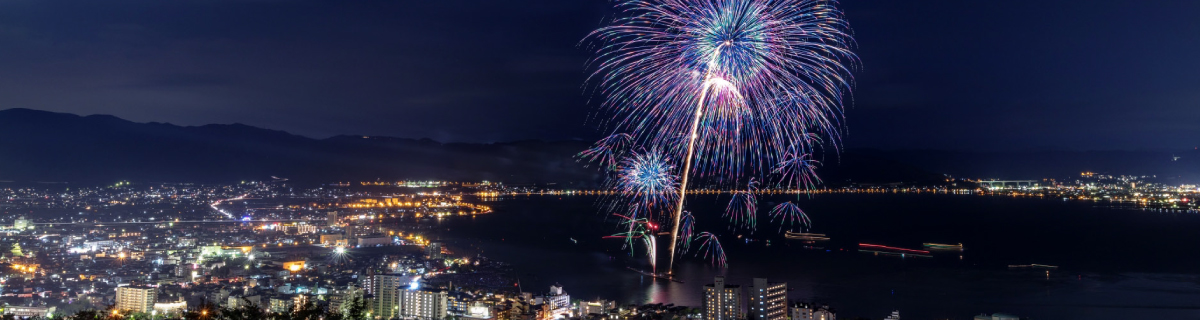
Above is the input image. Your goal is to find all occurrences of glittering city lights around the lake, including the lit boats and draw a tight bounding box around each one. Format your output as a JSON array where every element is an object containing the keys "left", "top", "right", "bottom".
[{"left": 0, "top": 173, "right": 1200, "bottom": 320}]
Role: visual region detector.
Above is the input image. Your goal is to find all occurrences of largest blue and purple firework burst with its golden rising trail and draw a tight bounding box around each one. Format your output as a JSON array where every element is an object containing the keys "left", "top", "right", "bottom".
[{"left": 588, "top": 0, "right": 857, "bottom": 272}]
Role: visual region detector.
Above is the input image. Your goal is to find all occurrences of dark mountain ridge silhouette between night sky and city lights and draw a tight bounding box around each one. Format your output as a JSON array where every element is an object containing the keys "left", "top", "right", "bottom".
[{"left": 0, "top": 109, "right": 1200, "bottom": 187}]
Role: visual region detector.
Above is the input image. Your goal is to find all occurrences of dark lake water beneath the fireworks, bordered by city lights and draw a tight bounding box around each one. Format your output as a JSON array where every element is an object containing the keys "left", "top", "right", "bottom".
[{"left": 439, "top": 194, "right": 1200, "bottom": 319}]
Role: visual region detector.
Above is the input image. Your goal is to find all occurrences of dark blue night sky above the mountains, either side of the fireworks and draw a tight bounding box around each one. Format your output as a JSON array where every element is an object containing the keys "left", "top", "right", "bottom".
[{"left": 0, "top": 0, "right": 1200, "bottom": 151}]
